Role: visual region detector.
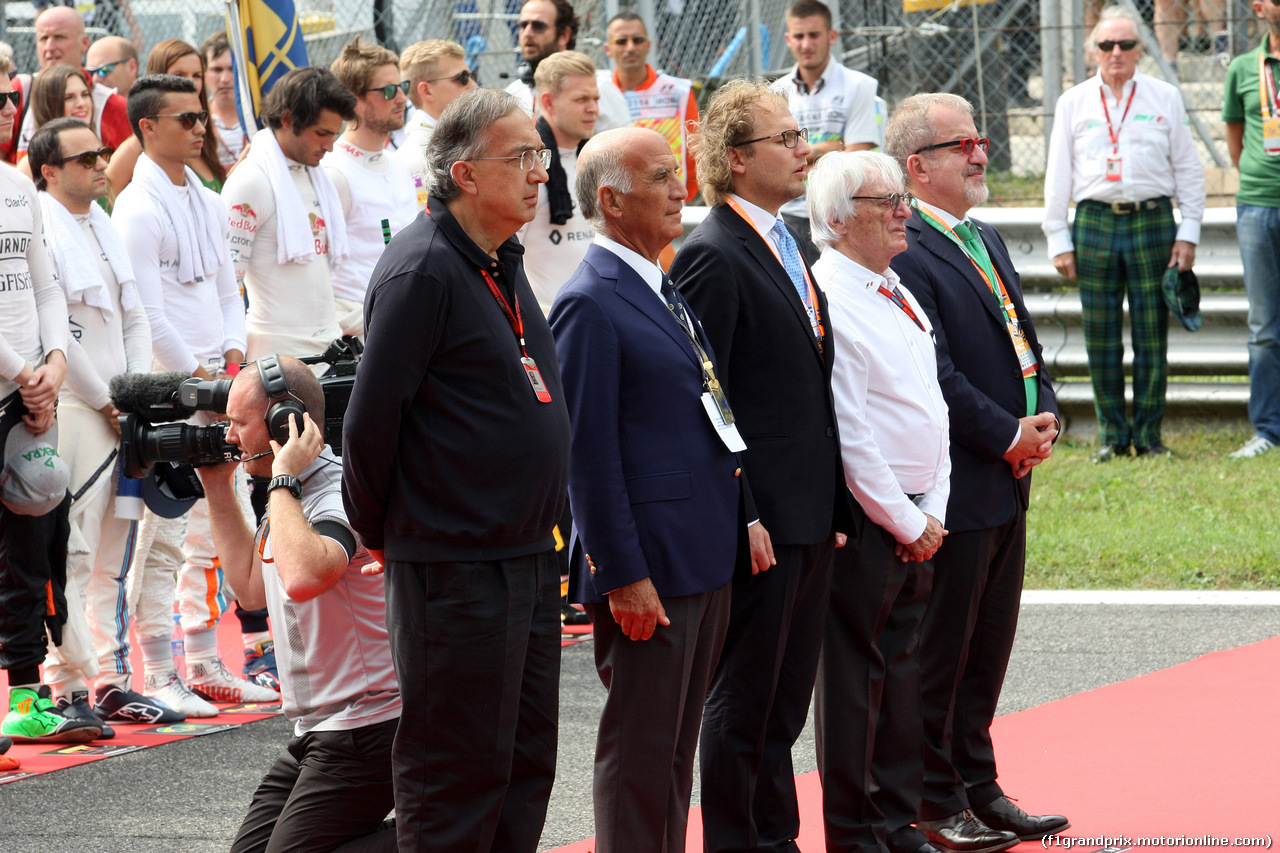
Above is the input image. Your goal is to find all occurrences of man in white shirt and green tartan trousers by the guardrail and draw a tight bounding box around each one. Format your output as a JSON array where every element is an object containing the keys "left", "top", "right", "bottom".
[{"left": 1043, "top": 6, "right": 1204, "bottom": 462}]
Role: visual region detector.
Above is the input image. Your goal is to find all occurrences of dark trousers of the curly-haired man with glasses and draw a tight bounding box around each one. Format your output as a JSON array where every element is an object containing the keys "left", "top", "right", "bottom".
[{"left": 700, "top": 535, "right": 835, "bottom": 853}]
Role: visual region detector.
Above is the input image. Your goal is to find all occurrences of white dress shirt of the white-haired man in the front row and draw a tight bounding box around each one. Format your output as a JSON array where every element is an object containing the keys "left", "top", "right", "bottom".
[{"left": 813, "top": 247, "right": 951, "bottom": 544}]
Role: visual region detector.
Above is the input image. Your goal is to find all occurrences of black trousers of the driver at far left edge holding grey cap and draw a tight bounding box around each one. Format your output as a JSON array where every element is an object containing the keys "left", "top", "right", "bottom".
[{"left": 0, "top": 391, "right": 72, "bottom": 684}]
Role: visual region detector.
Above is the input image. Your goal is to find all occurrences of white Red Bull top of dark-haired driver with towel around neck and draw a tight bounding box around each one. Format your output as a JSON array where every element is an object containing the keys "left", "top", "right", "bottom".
[{"left": 223, "top": 159, "right": 342, "bottom": 361}]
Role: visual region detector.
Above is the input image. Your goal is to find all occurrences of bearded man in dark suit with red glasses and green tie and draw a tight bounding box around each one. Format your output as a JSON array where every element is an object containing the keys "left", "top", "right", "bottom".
[{"left": 884, "top": 89, "right": 1069, "bottom": 853}]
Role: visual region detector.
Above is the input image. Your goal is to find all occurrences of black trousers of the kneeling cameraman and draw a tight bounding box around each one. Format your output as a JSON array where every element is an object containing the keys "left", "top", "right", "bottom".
[{"left": 232, "top": 720, "right": 398, "bottom": 853}]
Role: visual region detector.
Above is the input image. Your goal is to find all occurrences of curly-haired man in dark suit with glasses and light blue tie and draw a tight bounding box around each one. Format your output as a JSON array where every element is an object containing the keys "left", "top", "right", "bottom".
[{"left": 671, "top": 81, "right": 855, "bottom": 853}]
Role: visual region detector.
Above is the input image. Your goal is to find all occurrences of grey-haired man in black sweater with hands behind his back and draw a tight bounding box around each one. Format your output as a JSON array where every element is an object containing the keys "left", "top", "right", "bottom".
[{"left": 343, "top": 88, "right": 570, "bottom": 853}]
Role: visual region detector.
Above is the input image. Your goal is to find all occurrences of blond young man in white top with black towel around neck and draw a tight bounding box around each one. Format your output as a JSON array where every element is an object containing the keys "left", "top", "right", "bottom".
[{"left": 518, "top": 50, "right": 600, "bottom": 314}]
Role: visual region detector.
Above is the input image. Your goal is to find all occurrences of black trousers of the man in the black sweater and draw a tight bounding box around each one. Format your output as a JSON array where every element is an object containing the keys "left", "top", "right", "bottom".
[{"left": 387, "top": 549, "right": 559, "bottom": 853}]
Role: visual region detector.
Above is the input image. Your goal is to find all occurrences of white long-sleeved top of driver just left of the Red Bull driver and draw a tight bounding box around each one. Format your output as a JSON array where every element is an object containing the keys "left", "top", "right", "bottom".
[{"left": 111, "top": 182, "right": 244, "bottom": 373}]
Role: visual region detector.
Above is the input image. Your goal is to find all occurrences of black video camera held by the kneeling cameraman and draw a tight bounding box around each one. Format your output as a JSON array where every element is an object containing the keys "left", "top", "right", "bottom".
[{"left": 110, "top": 337, "right": 364, "bottom": 479}]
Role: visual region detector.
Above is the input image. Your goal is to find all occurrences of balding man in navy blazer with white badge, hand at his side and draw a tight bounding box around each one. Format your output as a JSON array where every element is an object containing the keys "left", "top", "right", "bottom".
[{"left": 550, "top": 128, "right": 748, "bottom": 853}]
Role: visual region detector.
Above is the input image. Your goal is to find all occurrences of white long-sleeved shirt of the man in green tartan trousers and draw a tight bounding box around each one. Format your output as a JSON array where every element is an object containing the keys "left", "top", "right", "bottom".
[{"left": 1042, "top": 72, "right": 1204, "bottom": 257}]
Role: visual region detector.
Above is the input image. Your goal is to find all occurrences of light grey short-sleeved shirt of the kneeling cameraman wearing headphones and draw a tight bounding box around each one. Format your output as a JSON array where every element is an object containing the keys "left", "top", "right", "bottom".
[{"left": 255, "top": 446, "right": 401, "bottom": 736}]
